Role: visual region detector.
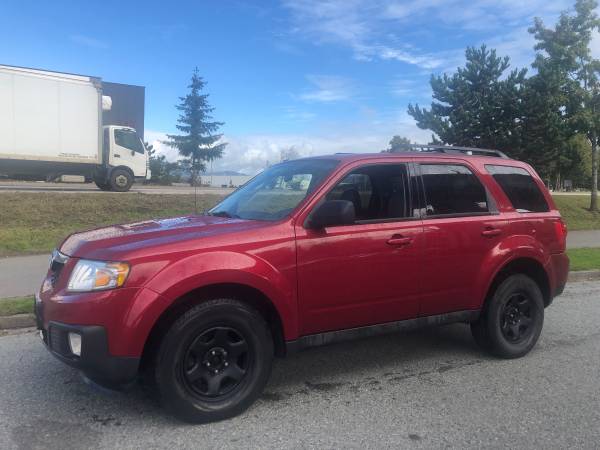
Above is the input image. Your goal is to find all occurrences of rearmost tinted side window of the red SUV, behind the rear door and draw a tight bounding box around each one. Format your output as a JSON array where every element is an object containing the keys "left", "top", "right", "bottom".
[{"left": 485, "top": 165, "right": 550, "bottom": 212}]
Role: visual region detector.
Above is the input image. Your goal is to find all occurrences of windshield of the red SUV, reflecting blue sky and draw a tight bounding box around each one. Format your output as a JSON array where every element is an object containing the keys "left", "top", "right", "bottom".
[{"left": 208, "top": 159, "right": 339, "bottom": 221}]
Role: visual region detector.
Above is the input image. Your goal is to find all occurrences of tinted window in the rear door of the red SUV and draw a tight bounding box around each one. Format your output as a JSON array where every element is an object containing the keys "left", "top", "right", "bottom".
[{"left": 421, "top": 164, "right": 489, "bottom": 216}]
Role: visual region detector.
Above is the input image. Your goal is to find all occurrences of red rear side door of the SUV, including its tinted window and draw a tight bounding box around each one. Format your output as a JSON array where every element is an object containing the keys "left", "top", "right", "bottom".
[{"left": 418, "top": 160, "right": 507, "bottom": 315}]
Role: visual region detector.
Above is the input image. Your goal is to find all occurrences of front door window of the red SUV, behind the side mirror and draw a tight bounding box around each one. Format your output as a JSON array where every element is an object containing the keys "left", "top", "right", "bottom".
[{"left": 327, "top": 164, "right": 412, "bottom": 221}]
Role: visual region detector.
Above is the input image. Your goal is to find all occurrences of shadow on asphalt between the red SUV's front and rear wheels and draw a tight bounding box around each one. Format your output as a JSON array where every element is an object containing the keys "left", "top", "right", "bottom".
[{"left": 263, "top": 324, "right": 488, "bottom": 399}]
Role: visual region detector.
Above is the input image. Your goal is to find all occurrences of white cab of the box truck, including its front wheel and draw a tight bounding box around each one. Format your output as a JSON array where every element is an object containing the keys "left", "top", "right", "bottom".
[{"left": 94, "top": 125, "right": 151, "bottom": 192}]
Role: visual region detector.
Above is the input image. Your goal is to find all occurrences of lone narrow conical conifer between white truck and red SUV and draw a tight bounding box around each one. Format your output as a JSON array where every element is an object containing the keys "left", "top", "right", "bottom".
[{"left": 165, "top": 68, "right": 227, "bottom": 186}]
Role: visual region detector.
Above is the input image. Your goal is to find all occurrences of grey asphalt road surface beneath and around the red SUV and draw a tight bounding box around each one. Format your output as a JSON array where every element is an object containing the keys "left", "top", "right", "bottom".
[{"left": 0, "top": 283, "right": 600, "bottom": 449}]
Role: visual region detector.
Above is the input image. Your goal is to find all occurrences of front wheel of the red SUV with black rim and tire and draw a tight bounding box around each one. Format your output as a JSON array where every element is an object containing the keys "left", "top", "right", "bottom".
[{"left": 155, "top": 299, "right": 273, "bottom": 423}]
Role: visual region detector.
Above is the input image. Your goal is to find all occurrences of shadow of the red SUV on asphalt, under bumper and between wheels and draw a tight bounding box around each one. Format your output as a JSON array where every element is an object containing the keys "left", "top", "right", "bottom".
[{"left": 22, "top": 324, "right": 489, "bottom": 428}]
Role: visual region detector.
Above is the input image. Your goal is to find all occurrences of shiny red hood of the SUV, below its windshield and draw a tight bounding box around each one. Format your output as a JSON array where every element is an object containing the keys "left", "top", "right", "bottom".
[{"left": 60, "top": 216, "right": 265, "bottom": 260}]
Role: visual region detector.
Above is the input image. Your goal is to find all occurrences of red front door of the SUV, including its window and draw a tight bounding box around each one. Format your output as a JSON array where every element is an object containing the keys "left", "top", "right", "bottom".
[{"left": 296, "top": 163, "right": 423, "bottom": 335}]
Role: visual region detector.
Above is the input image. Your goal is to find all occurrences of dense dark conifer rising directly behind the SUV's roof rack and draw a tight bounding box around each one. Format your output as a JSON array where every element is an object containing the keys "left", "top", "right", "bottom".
[{"left": 408, "top": 45, "right": 526, "bottom": 154}]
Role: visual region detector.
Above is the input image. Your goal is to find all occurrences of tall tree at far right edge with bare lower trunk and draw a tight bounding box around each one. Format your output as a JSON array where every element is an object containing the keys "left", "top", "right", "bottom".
[{"left": 530, "top": 0, "right": 600, "bottom": 211}]
